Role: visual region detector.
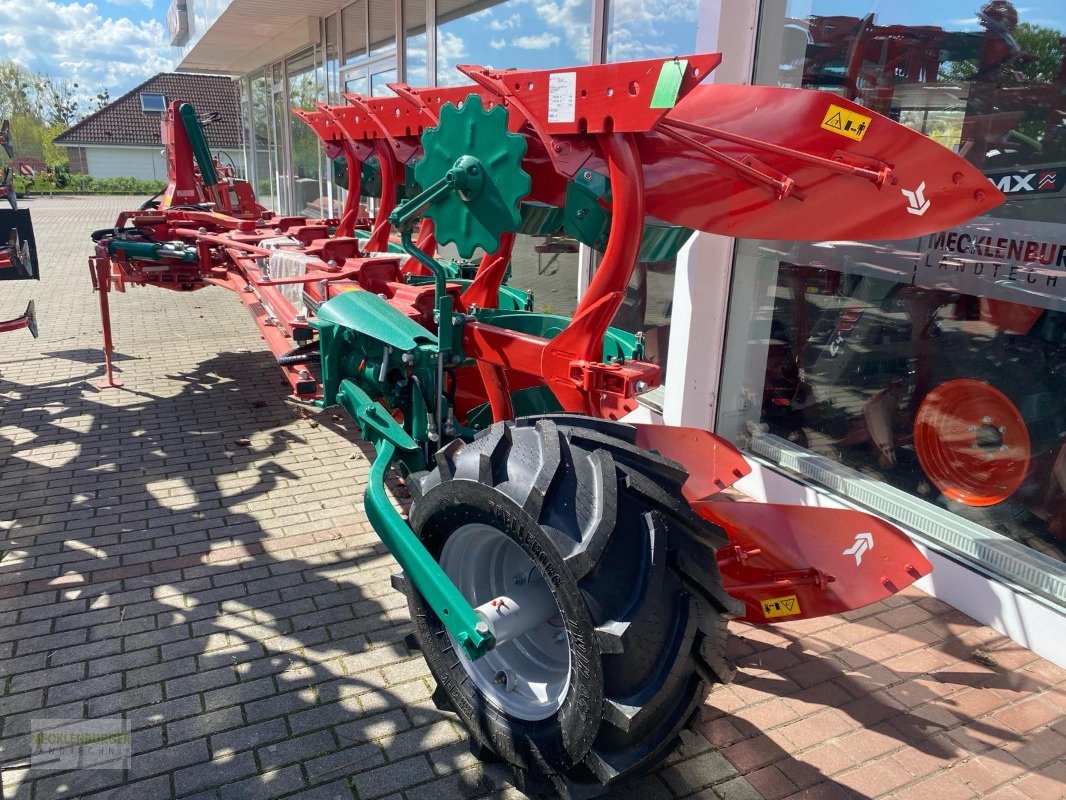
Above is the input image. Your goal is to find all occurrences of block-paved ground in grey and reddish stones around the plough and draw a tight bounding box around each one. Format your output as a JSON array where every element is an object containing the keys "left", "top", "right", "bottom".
[{"left": 0, "top": 197, "right": 1066, "bottom": 800}]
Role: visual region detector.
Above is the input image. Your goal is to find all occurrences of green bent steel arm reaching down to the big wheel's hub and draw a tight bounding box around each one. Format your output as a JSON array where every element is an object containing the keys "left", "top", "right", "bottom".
[{"left": 338, "top": 381, "right": 495, "bottom": 658}]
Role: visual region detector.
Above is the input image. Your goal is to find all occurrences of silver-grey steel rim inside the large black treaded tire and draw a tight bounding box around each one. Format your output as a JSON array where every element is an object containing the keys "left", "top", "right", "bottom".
[{"left": 440, "top": 523, "right": 570, "bottom": 722}]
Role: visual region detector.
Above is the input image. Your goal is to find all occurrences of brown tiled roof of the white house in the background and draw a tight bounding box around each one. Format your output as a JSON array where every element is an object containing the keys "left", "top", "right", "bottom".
[{"left": 55, "top": 73, "right": 241, "bottom": 148}]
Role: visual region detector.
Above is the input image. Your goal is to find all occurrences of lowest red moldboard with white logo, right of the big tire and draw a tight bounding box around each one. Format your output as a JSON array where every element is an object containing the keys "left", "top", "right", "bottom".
[{"left": 692, "top": 501, "right": 933, "bottom": 624}]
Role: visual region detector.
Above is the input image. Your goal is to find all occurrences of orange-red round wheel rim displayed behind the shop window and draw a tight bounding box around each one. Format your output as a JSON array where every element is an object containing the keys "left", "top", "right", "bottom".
[{"left": 915, "top": 379, "right": 1031, "bottom": 508}]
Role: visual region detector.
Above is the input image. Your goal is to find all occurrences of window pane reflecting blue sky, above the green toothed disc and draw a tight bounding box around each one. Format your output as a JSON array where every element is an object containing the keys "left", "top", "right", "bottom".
[{"left": 437, "top": 0, "right": 592, "bottom": 86}]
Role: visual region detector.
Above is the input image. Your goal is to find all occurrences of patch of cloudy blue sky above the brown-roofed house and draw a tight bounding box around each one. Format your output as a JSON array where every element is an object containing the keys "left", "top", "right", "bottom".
[{"left": 0, "top": 0, "right": 174, "bottom": 99}]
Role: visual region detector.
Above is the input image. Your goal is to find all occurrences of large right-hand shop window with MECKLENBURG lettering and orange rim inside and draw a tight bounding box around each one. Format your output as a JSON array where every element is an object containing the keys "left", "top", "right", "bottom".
[{"left": 718, "top": 0, "right": 1066, "bottom": 582}]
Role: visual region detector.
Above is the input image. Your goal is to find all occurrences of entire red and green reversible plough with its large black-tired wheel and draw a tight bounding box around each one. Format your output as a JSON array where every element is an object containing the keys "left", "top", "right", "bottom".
[{"left": 91, "top": 54, "right": 1002, "bottom": 797}]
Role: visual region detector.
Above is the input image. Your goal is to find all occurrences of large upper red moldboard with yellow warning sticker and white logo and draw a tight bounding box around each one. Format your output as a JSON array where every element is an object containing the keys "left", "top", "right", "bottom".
[{"left": 640, "top": 84, "right": 1004, "bottom": 241}]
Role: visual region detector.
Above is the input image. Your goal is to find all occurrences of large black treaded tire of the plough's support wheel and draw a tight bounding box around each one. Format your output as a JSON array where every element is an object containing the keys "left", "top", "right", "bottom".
[{"left": 406, "top": 414, "right": 743, "bottom": 798}]
